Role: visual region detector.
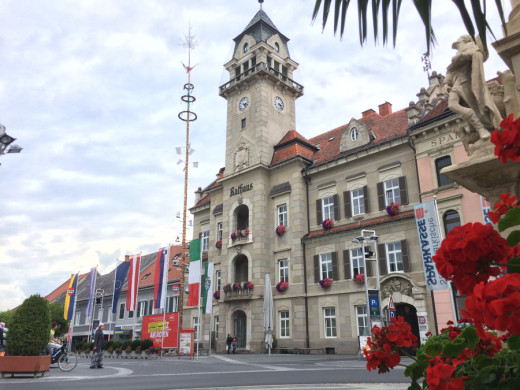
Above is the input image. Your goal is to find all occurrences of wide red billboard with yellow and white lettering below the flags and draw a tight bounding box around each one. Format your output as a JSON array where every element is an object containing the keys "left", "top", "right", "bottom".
[{"left": 143, "top": 313, "right": 179, "bottom": 348}]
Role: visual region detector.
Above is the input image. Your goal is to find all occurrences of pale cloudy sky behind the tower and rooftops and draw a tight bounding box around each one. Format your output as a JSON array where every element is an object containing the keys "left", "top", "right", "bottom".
[{"left": 0, "top": 0, "right": 510, "bottom": 311}]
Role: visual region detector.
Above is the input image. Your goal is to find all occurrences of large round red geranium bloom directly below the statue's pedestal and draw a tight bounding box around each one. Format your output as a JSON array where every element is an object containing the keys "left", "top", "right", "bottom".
[{"left": 433, "top": 222, "right": 511, "bottom": 295}]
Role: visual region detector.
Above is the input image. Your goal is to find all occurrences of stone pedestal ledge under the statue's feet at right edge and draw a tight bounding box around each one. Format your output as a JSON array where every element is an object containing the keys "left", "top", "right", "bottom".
[{"left": 441, "top": 148, "right": 520, "bottom": 207}]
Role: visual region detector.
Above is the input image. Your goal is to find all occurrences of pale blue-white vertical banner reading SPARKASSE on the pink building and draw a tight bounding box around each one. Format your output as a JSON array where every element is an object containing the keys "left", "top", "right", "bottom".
[{"left": 414, "top": 200, "right": 448, "bottom": 290}]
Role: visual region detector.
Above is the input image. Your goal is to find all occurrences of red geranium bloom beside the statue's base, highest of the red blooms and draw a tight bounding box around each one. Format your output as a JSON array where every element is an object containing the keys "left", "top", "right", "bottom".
[{"left": 491, "top": 114, "right": 520, "bottom": 164}]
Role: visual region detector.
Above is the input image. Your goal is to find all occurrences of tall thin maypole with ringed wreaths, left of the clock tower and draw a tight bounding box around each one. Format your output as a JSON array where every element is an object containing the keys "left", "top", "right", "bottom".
[{"left": 177, "top": 26, "right": 197, "bottom": 348}]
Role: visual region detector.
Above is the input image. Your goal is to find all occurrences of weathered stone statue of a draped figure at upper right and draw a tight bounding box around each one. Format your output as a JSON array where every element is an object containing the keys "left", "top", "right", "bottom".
[{"left": 444, "top": 35, "right": 502, "bottom": 156}]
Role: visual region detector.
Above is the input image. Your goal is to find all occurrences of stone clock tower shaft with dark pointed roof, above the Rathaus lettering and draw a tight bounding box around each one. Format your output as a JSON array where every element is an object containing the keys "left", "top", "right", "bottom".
[{"left": 219, "top": 9, "right": 303, "bottom": 176}]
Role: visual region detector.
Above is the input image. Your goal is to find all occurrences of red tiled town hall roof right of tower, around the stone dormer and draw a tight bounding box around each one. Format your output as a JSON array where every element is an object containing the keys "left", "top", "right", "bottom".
[{"left": 309, "top": 110, "right": 408, "bottom": 165}]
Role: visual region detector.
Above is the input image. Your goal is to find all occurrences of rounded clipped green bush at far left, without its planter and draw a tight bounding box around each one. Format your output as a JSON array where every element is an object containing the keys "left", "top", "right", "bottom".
[{"left": 7, "top": 295, "right": 51, "bottom": 356}]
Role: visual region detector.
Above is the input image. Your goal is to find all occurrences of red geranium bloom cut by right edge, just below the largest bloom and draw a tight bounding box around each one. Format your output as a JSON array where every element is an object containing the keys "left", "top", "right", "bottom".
[{"left": 462, "top": 273, "right": 520, "bottom": 337}]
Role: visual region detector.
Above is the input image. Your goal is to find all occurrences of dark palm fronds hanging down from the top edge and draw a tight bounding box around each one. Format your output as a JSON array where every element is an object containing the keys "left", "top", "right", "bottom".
[{"left": 312, "top": 0, "right": 507, "bottom": 53}]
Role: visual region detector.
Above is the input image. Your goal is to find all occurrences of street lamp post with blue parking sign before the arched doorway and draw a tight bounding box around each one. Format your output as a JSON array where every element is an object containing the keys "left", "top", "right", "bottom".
[{"left": 352, "top": 230, "right": 383, "bottom": 332}]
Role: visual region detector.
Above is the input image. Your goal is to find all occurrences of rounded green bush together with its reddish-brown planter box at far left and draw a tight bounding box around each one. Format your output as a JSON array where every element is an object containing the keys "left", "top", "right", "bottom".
[{"left": 0, "top": 295, "right": 51, "bottom": 376}]
